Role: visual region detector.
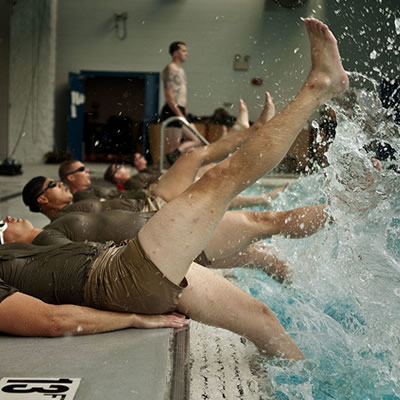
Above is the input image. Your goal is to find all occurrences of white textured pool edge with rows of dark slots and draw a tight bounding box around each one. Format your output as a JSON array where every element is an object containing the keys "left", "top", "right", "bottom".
[{"left": 190, "top": 321, "right": 272, "bottom": 400}]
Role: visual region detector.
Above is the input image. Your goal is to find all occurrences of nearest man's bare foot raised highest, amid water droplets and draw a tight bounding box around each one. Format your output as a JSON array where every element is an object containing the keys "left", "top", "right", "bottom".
[{"left": 304, "top": 18, "right": 349, "bottom": 104}]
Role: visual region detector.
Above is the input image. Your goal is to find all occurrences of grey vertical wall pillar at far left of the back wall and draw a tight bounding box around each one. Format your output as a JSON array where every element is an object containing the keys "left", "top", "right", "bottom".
[{"left": 9, "top": 0, "right": 57, "bottom": 162}]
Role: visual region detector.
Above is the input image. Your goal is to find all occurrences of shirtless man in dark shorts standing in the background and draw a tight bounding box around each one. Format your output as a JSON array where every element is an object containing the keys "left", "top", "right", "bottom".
[{"left": 161, "top": 42, "right": 200, "bottom": 165}]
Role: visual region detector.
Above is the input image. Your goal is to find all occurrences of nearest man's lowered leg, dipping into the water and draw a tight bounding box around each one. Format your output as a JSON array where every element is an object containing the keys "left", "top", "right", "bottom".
[{"left": 178, "top": 263, "right": 304, "bottom": 360}]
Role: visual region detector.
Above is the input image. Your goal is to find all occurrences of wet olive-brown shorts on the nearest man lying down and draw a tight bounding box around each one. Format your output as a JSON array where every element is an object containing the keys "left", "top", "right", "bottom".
[{"left": 84, "top": 237, "right": 188, "bottom": 314}]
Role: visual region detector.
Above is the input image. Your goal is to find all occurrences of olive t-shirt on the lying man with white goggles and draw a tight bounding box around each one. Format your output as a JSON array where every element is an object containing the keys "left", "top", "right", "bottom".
[{"left": 32, "top": 210, "right": 154, "bottom": 245}]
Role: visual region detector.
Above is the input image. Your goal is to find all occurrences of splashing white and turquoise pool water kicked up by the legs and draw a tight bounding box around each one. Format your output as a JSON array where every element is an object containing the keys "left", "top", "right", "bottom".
[{"left": 238, "top": 76, "right": 400, "bottom": 400}]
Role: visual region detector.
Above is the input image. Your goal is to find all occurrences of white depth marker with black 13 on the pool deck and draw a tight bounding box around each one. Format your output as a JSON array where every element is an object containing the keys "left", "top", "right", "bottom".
[{"left": 0, "top": 378, "right": 81, "bottom": 400}]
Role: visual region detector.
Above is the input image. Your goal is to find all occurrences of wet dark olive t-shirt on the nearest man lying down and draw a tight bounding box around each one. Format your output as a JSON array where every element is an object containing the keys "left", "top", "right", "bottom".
[{"left": 0, "top": 243, "right": 108, "bottom": 305}]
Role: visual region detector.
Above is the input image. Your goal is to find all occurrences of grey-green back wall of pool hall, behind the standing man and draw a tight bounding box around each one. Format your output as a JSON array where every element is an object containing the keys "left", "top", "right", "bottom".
[{"left": 6, "top": 0, "right": 400, "bottom": 160}]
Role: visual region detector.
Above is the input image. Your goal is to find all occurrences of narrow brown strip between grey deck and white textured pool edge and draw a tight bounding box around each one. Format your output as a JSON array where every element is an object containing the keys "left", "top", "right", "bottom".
[{"left": 169, "top": 327, "right": 190, "bottom": 400}]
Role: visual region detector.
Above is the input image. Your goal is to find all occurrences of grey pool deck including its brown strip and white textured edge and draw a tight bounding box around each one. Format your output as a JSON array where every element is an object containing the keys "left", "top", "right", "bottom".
[{"left": 0, "top": 163, "right": 295, "bottom": 400}]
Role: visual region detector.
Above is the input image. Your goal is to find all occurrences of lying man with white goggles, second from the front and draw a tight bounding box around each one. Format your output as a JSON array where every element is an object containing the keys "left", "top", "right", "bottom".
[{"left": 3, "top": 192, "right": 327, "bottom": 282}]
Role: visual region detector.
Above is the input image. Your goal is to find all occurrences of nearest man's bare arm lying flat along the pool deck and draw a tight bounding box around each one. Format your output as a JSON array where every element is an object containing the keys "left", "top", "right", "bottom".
[{"left": 0, "top": 292, "right": 189, "bottom": 337}]
